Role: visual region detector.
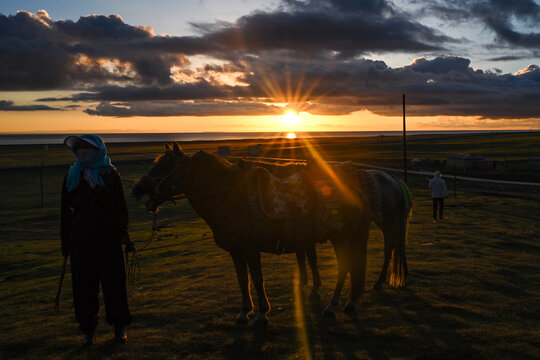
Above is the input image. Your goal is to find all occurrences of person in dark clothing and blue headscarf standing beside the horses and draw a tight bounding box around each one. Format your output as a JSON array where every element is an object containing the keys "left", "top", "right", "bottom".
[{"left": 61, "top": 135, "right": 133, "bottom": 345}]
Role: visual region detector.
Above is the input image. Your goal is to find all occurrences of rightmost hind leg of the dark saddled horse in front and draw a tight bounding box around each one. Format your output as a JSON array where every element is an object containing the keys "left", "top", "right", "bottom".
[{"left": 343, "top": 222, "right": 369, "bottom": 313}]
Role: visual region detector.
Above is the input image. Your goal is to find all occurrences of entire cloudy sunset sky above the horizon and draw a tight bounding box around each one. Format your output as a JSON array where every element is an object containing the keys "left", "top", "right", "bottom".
[{"left": 0, "top": 0, "right": 540, "bottom": 133}]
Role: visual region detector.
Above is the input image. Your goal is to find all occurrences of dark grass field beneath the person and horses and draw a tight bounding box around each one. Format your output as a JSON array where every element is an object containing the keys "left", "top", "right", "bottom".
[{"left": 0, "top": 139, "right": 540, "bottom": 359}]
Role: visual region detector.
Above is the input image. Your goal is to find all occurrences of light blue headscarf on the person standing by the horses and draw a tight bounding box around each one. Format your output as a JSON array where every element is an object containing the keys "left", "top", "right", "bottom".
[{"left": 64, "top": 135, "right": 116, "bottom": 191}]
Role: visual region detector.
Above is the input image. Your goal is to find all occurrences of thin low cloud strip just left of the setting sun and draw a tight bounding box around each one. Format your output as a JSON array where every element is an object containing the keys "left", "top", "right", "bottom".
[{"left": 85, "top": 101, "right": 283, "bottom": 117}]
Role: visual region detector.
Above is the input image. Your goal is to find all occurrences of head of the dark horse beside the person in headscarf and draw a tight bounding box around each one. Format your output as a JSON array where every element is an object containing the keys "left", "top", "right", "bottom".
[{"left": 131, "top": 142, "right": 190, "bottom": 212}]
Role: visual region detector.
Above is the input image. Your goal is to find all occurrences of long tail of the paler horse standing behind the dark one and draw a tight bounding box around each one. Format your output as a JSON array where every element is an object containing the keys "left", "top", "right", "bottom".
[{"left": 390, "top": 179, "right": 412, "bottom": 287}]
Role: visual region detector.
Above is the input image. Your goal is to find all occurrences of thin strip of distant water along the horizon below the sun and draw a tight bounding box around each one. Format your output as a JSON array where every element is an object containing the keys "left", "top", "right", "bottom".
[{"left": 0, "top": 130, "right": 532, "bottom": 145}]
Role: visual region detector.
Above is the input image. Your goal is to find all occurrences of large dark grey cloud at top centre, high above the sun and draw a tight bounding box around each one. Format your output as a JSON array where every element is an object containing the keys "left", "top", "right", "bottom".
[{"left": 196, "top": 1, "right": 454, "bottom": 57}]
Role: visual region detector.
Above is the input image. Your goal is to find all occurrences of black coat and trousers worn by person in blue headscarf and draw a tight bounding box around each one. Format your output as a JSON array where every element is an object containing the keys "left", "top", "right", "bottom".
[{"left": 61, "top": 170, "right": 131, "bottom": 331}]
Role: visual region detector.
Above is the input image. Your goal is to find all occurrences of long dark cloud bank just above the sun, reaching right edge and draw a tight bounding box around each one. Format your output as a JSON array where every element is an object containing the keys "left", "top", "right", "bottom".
[{"left": 42, "top": 57, "right": 540, "bottom": 119}]
